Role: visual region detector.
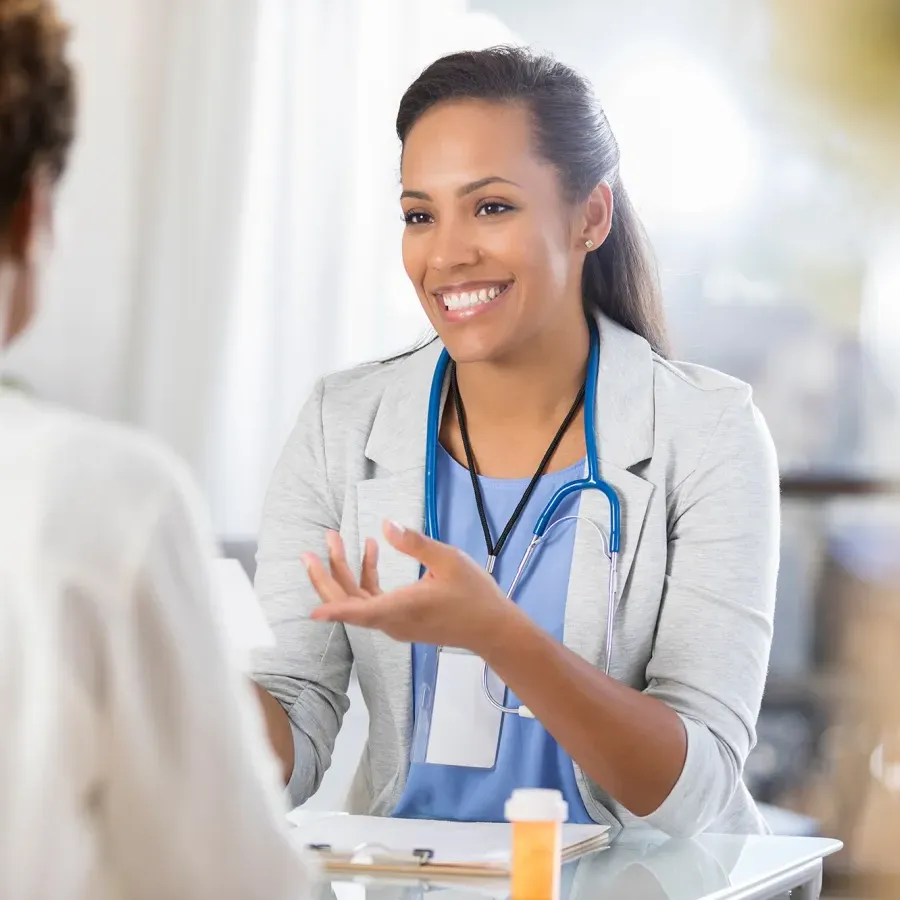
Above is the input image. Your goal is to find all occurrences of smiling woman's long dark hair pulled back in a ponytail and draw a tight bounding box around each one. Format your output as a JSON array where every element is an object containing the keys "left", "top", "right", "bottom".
[{"left": 397, "top": 46, "right": 668, "bottom": 355}]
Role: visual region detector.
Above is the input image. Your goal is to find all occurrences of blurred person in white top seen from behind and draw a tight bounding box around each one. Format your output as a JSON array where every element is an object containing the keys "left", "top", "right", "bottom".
[{"left": 0, "top": 0, "right": 306, "bottom": 900}]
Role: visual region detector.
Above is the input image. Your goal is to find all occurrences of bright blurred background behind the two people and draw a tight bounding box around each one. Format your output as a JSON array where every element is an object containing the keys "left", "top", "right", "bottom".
[{"left": 5, "top": 0, "right": 900, "bottom": 893}]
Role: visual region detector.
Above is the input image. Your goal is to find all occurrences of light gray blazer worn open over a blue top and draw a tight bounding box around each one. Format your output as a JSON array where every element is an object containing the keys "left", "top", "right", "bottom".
[{"left": 254, "top": 318, "right": 779, "bottom": 836}]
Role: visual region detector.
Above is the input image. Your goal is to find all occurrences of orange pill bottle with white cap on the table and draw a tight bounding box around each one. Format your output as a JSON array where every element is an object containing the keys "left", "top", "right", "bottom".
[{"left": 505, "top": 788, "right": 569, "bottom": 900}]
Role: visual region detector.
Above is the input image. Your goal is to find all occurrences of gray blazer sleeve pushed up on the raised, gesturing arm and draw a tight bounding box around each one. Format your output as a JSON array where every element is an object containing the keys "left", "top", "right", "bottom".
[{"left": 646, "top": 388, "right": 780, "bottom": 837}]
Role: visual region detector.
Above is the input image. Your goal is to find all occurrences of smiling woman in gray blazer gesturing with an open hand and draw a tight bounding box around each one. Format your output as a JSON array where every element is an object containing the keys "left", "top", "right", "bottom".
[{"left": 255, "top": 48, "right": 779, "bottom": 835}]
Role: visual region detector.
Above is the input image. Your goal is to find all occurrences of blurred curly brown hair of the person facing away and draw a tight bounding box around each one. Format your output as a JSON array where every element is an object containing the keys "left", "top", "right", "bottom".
[{"left": 0, "top": 0, "right": 75, "bottom": 226}]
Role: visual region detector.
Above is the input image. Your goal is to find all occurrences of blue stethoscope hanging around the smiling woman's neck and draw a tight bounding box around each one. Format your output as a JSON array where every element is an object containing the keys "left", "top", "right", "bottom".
[{"left": 425, "top": 322, "right": 622, "bottom": 719}]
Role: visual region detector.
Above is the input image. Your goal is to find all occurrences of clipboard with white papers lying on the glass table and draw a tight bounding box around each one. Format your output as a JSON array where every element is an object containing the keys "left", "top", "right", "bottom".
[{"left": 293, "top": 816, "right": 610, "bottom": 882}]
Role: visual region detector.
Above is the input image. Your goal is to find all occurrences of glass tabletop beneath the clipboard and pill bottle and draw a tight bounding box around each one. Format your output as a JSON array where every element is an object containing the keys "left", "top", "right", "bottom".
[{"left": 313, "top": 835, "right": 841, "bottom": 900}]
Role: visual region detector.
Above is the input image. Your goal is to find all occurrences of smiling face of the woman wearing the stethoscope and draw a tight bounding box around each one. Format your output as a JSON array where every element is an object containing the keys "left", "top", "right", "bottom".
[{"left": 401, "top": 101, "right": 585, "bottom": 362}]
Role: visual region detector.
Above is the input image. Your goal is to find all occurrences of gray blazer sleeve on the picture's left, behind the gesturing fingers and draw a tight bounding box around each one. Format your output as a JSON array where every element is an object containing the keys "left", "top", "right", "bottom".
[{"left": 252, "top": 381, "right": 353, "bottom": 805}]
